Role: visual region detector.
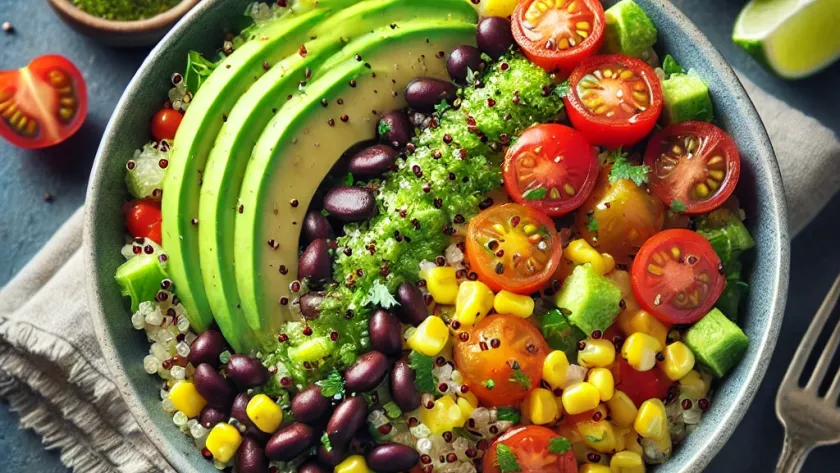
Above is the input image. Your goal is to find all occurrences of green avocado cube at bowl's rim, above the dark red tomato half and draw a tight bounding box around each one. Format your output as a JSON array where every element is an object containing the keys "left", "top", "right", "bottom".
[{"left": 662, "top": 74, "right": 715, "bottom": 125}]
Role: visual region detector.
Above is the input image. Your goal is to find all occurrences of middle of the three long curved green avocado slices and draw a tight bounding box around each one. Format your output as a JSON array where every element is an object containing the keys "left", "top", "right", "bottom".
[{"left": 193, "top": 0, "right": 477, "bottom": 350}]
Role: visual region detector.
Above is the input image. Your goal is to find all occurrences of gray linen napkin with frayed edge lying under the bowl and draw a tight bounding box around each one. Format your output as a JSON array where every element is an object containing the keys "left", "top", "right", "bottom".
[{"left": 0, "top": 77, "right": 840, "bottom": 473}]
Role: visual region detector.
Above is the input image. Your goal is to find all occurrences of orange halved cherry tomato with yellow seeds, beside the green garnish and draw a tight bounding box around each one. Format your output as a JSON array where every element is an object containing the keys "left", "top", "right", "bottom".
[{"left": 467, "top": 204, "right": 563, "bottom": 294}]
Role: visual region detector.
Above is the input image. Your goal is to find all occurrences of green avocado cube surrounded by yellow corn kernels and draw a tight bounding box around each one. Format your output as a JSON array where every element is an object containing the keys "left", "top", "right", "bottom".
[{"left": 554, "top": 264, "right": 621, "bottom": 335}]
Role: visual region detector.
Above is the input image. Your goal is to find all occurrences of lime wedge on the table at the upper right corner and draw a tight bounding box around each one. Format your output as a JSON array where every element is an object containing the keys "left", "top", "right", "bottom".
[{"left": 732, "top": 0, "right": 840, "bottom": 79}]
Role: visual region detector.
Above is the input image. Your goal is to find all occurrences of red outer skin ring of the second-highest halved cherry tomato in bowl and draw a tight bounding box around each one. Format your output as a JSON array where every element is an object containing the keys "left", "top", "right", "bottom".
[{"left": 563, "top": 54, "right": 663, "bottom": 148}]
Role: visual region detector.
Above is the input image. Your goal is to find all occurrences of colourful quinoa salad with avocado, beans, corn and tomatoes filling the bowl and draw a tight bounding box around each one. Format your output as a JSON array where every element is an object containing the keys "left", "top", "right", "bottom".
[{"left": 115, "top": 0, "right": 754, "bottom": 473}]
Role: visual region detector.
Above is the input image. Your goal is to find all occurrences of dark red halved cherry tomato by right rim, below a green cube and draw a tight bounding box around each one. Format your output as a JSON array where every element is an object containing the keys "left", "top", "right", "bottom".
[{"left": 645, "top": 122, "right": 741, "bottom": 215}]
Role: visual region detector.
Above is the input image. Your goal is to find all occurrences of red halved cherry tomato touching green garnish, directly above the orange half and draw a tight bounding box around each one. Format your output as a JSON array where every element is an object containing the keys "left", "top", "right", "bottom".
[{"left": 503, "top": 124, "right": 598, "bottom": 217}]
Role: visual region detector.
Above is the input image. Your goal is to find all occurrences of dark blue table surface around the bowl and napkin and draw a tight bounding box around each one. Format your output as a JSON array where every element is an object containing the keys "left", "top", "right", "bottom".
[{"left": 0, "top": 0, "right": 840, "bottom": 473}]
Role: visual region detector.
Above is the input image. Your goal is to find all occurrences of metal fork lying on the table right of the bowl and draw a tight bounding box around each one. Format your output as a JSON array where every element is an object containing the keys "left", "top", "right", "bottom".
[{"left": 776, "top": 276, "right": 840, "bottom": 473}]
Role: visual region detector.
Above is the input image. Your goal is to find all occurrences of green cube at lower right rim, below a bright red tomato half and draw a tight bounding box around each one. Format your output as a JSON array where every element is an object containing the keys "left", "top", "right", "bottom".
[{"left": 683, "top": 309, "right": 750, "bottom": 378}]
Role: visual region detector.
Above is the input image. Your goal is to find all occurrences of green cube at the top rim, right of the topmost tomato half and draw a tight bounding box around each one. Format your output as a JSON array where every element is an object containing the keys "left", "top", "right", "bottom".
[{"left": 604, "top": 0, "right": 657, "bottom": 57}]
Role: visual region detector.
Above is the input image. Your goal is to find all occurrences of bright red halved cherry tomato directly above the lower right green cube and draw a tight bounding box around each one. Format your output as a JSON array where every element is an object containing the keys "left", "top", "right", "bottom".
[{"left": 631, "top": 229, "right": 726, "bottom": 324}]
